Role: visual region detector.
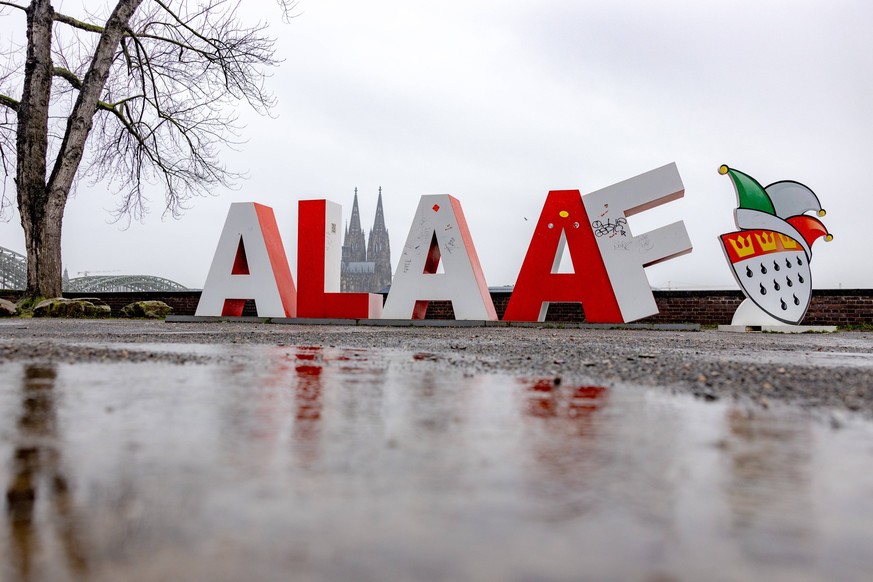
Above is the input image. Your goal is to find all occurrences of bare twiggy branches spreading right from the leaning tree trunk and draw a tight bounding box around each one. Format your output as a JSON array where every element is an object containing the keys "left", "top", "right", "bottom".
[{"left": 65, "top": 0, "right": 278, "bottom": 219}]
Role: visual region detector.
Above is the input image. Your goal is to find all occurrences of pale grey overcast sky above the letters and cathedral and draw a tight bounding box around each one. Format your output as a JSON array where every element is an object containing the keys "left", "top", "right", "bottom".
[{"left": 0, "top": 0, "right": 873, "bottom": 289}]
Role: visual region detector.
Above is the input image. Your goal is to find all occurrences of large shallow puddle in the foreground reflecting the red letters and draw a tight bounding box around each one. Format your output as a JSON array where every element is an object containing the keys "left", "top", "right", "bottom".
[{"left": 0, "top": 344, "right": 873, "bottom": 581}]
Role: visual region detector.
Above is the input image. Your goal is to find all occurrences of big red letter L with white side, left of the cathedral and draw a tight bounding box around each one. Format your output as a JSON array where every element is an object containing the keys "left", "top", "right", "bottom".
[{"left": 297, "top": 200, "right": 382, "bottom": 319}]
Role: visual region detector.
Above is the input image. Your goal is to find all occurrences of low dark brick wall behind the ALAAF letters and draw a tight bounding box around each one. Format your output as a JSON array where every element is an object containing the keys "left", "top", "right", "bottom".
[{"left": 0, "top": 289, "right": 873, "bottom": 325}]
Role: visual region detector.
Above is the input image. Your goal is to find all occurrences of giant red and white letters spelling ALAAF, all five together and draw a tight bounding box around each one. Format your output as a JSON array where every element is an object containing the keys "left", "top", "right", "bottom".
[{"left": 196, "top": 164, "right": 691, "bottom": 323}]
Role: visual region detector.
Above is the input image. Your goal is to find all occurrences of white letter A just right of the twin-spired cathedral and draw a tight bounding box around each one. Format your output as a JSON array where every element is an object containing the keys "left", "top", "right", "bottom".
[{"left": 382, "top": 194, "right": 497, "bottom": 321}]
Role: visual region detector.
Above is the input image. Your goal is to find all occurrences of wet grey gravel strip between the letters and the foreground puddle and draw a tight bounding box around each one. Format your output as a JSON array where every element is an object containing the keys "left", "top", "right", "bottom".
[{"left": 0, "top": 319, "right": 873, "bottom": 417}]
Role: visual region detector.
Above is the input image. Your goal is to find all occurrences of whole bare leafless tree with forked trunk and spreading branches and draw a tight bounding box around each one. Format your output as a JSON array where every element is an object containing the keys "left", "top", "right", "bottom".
[{"left": 0, "top": 0, "right": 295, "bottom": 297}]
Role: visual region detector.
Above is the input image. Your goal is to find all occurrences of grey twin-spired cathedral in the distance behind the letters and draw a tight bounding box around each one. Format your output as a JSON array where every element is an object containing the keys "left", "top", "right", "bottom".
[{"left": 340, "top": 186, "right": 391, "bottom": 293}]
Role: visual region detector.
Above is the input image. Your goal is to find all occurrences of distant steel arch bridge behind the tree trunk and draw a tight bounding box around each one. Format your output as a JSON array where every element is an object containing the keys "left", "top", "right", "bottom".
[{"left": 0, "top": 247, "right": 188, "bottom": 293}]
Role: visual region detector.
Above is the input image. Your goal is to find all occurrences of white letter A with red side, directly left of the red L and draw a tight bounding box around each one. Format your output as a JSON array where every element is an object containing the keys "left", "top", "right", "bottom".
[{"left": 196, "top": 202, "right": 297, "bottom": 317}]
